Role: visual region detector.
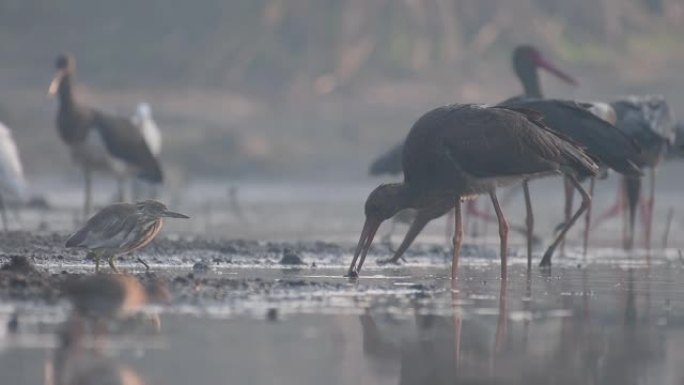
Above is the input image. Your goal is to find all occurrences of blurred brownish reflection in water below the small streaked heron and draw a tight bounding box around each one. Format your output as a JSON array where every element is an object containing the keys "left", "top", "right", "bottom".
[{"left": 44, "top": 274, "right": 169, "bottom": 385}]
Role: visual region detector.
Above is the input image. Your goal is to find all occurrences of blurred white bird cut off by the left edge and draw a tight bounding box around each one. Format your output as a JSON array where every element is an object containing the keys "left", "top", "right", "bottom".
[{"left": 0, "top": 122, "right": 26, "bottom": 231}]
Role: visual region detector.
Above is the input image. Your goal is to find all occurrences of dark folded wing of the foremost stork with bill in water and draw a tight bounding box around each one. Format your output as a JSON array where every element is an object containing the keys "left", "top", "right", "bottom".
[{"left": 404, "top": 105, "right": 598, "bottom": 184}]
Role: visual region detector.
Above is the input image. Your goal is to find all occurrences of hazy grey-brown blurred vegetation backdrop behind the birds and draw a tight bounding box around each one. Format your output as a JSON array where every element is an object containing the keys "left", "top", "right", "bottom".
[{"left": 0, "top": 0, "right": 684, "bottom": 178}]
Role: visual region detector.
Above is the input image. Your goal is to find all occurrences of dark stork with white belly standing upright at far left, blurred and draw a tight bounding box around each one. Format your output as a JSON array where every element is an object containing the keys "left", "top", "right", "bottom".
[{"left": 48, "top": 54, "right": 163, "bottom": 217}]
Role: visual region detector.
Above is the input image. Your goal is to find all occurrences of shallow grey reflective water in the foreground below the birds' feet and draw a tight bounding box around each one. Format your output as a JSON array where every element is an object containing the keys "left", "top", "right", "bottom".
[{"left": 0, "top": 259, "right": 684, "bottom": 385}]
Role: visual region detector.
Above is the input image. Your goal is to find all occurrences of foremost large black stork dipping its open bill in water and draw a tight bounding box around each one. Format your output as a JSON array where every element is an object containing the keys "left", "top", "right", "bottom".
[{"left": 347, "top": 105, "right": 598, "bottom": 278}]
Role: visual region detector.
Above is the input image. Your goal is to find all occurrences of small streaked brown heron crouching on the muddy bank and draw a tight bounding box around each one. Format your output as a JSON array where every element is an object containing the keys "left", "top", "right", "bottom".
[{"left": 66, "top": 200, "right": 190, "bottom": 272}]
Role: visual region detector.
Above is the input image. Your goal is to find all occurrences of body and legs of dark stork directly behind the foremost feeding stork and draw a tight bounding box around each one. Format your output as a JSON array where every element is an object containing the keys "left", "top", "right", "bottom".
[{"left": 500, "top": 98, "right": 641, "bottom": 267}]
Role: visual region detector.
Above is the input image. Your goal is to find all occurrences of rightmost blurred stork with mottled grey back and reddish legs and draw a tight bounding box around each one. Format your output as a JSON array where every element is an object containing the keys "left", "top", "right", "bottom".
[{"left": 596, "top": 95, "right": 677, "bottom": 250}]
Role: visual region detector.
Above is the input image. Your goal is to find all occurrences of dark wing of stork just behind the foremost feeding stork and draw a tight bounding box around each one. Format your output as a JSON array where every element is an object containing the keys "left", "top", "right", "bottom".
[{"left": 503, "top": 99, "right": 641, "bottom": 176}]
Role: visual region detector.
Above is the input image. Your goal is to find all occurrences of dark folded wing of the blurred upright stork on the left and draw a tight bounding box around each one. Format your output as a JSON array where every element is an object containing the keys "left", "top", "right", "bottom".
[{"left": 94, "top": 112, "right": 163, "bottom": 183}]
